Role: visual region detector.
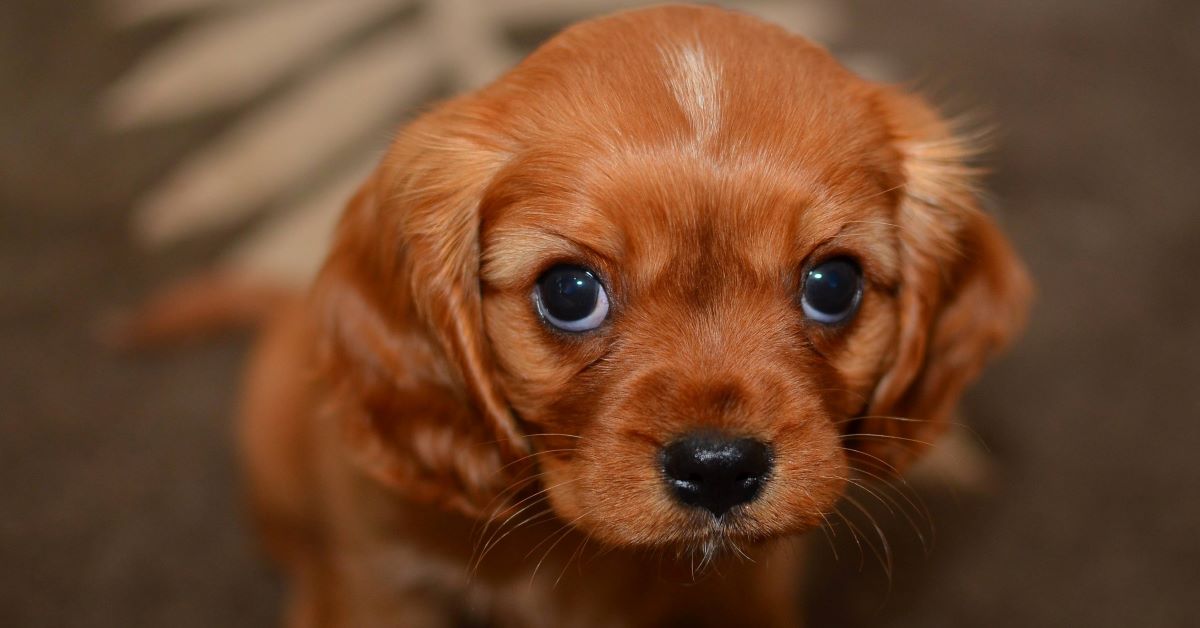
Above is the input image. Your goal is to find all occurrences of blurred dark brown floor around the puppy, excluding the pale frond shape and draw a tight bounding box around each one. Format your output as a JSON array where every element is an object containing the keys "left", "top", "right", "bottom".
[{"left": 0, "top": 0, "right": 1200, "bottom": 628}]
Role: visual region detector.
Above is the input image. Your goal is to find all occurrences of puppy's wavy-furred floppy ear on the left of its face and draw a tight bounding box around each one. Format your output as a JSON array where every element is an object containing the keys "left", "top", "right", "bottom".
[{"left": 313, "top": 103, "right": 526, "bottom": 515}]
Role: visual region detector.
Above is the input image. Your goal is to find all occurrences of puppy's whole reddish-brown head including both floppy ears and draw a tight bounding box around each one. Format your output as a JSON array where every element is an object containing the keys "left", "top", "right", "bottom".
[{"left": 317, "top": 7, "right": 1027, "bottom": 546}]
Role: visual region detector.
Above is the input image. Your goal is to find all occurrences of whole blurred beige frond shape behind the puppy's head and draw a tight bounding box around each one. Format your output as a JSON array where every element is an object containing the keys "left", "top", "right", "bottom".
[{"left": 110, "top": 0, "right": 882, "bottom": 290}]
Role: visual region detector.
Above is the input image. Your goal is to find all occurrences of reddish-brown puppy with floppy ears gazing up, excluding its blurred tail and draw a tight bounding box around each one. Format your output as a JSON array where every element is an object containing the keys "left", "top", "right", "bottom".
[{"left": 241, "top": 6, "right": 1030, "bottom": 627}]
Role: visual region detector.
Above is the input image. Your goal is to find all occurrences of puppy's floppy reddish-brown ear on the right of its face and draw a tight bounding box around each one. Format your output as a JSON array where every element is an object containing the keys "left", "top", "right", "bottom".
[{"left": 854, "top": 92, "right": 1032, "bottom": 468}]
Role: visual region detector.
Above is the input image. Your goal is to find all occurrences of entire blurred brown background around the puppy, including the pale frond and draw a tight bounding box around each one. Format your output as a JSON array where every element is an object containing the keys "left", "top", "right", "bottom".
[{"left": 0, "top": 0, "right": 1200, "bottom": 628}]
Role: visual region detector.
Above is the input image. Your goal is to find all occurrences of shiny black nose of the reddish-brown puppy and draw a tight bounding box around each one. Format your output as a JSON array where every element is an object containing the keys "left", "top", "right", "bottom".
[{"left": 662, "top": 435, "right": 770, "bottom": 516}]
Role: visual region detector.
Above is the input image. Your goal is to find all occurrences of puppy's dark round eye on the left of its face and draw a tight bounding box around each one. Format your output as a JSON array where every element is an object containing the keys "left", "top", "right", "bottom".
[{"left": 534, "top": 265, "right": 608, "bottom": 331}]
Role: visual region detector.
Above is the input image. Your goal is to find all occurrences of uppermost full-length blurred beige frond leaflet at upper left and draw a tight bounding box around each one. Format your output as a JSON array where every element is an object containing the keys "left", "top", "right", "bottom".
[{"left": 102, "top": 0, "right": 401, "bottom": 128}]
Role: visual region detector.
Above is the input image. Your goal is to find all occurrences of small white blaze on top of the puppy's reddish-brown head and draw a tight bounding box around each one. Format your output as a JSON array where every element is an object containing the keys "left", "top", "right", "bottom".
[{"left": 662, "top": 42, "right": 721, "bottom": 142}]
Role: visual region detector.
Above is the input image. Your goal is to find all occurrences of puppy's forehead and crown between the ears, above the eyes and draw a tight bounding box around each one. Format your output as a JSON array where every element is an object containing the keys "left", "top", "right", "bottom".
[{"left": 482, "top": 7, "right": 898, "bottom": 289}]
